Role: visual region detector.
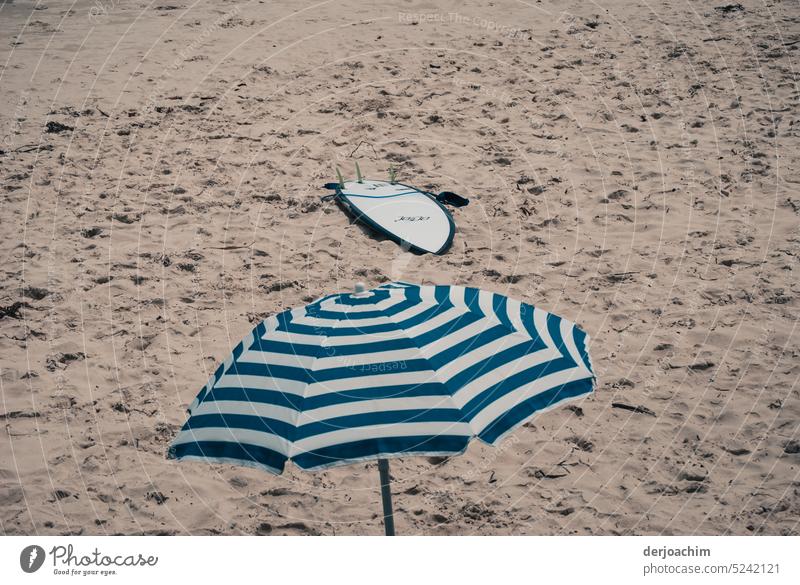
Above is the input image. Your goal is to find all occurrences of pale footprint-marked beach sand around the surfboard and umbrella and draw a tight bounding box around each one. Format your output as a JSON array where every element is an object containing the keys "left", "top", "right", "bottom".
[{"left": 0, "top": 0, "right": 800, "bottom": 535}]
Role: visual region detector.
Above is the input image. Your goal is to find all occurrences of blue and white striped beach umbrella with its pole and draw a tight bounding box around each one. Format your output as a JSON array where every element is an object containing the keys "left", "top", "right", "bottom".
[{"left": 168, "top": 282, "right": 594, "bottom": 534}]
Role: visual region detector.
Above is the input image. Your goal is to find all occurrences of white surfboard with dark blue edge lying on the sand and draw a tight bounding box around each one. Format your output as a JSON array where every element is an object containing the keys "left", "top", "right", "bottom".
[{"left": 336, "top": 179, "right": 455, "bottom": 254}]
